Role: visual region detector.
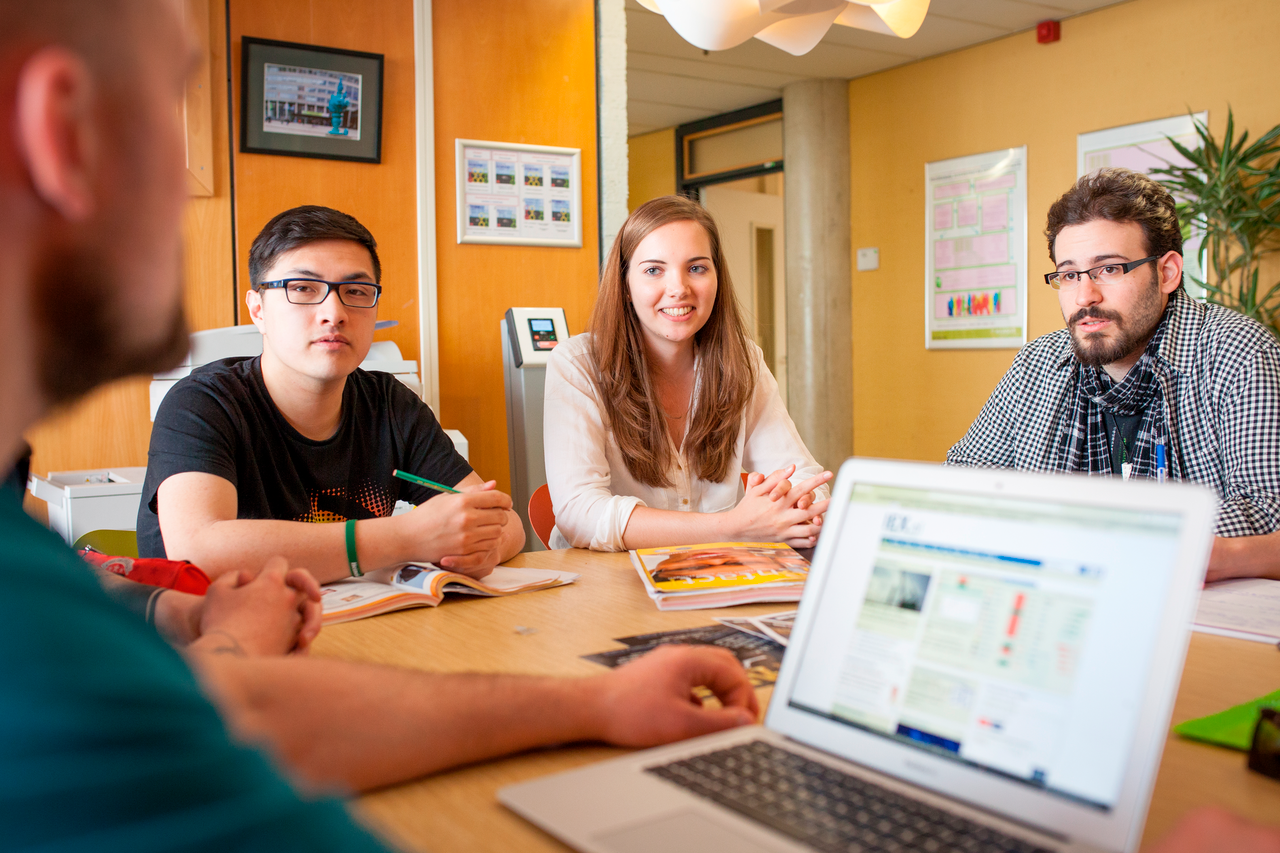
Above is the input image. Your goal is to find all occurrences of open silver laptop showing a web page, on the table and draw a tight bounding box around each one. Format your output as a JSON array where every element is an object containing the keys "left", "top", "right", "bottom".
[{"left": 499, "top": 459, "right": 1216, "bottom": 853}]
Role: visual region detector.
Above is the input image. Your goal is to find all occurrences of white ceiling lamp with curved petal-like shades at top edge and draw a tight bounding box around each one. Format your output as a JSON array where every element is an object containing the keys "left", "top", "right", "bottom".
[{"left": 637, "top": 0, "right": 929, "bottom": 56}]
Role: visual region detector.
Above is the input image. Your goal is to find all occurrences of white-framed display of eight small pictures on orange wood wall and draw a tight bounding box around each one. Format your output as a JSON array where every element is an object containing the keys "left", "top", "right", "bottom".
[{"left": 456, "top": 140, "right": 582, "bottom": 247}]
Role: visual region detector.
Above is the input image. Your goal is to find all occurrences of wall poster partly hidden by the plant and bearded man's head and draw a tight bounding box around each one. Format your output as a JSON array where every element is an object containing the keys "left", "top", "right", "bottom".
[{"left": 1075, "top": 111, "right": 1208, "bottom": 300}]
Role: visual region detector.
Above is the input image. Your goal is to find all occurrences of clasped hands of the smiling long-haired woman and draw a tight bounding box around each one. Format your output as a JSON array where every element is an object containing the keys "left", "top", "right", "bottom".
[{"left": 730, "top": 465, "right": 832, "bottom": 548}]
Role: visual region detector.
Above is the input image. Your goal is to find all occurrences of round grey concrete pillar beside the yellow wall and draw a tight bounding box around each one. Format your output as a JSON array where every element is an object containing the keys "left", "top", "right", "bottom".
[{"left": 782, "top": 79, "right": 854, "bottom": 470}]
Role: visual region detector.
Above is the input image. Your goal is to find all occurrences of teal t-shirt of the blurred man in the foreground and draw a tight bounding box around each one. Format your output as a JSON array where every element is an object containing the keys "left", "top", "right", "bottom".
[{"left": 0, "top": 494, "right": 385, "bottom": 853}]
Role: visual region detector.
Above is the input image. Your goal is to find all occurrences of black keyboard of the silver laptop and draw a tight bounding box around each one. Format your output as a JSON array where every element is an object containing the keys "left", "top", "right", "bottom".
[{"left": 648, "top": 740, "right": 1050, "bottom": 853}]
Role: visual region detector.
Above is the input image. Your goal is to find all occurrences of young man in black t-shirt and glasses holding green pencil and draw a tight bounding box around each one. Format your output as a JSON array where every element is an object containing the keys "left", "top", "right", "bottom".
[{"left": 138, "top": 206, "right": 525, "bottom": 583}]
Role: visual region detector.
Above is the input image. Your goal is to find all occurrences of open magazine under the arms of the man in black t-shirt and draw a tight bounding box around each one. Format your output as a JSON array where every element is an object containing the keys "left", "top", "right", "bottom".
[{"left": 320, "top": 562, "right": 580, "bottom": 625}]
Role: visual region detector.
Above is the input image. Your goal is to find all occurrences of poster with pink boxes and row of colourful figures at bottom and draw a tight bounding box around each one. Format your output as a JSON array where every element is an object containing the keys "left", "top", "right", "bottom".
[{"left": 924, "top": 146, "right": 1027, "bottom": 350}]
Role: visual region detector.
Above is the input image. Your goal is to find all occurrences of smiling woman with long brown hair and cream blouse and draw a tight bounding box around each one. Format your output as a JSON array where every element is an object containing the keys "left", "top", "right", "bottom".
[{"left": 544, "top": 196, "right": 832, "bottom": 551}]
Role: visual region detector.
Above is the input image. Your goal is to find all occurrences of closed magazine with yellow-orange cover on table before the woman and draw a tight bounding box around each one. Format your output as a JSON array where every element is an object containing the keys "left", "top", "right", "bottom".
[{"left": 631, "top": 542, "right": 809, "bottom": 610}]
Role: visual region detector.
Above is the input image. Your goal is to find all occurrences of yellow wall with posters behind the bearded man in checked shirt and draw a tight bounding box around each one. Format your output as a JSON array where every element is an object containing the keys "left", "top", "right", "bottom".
[{"left": 849, "top": 0, "right": 1280, "bottom": 460}]
